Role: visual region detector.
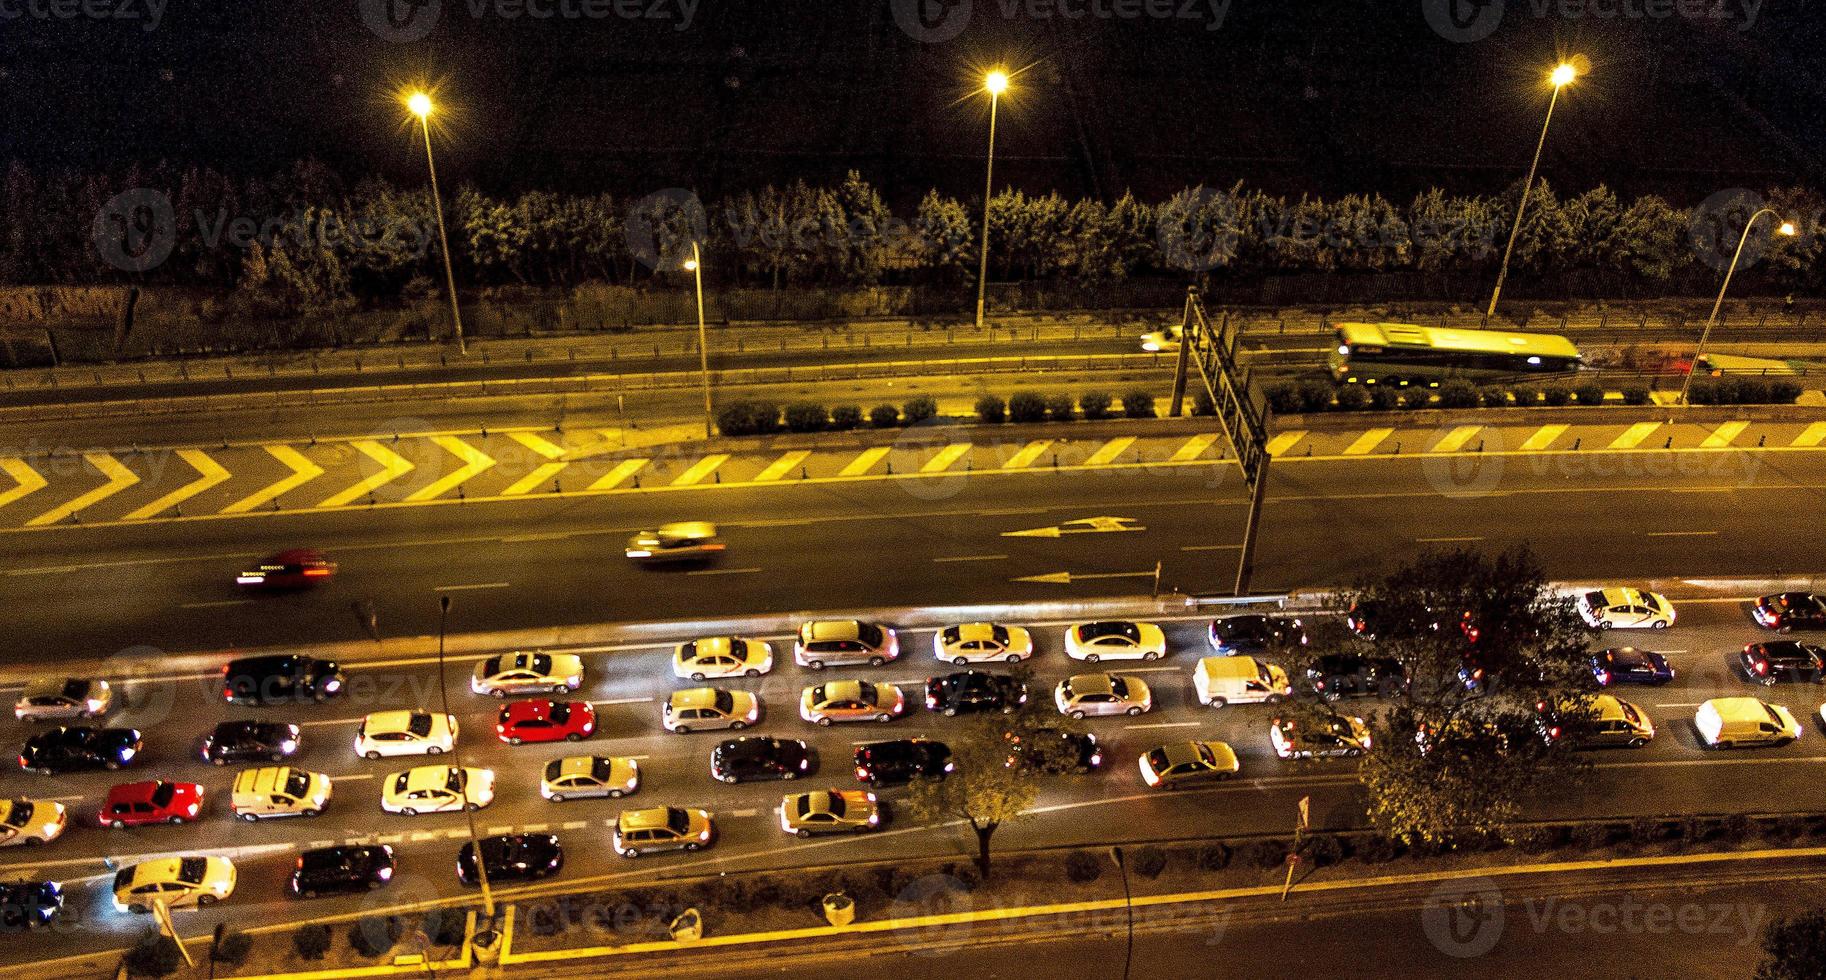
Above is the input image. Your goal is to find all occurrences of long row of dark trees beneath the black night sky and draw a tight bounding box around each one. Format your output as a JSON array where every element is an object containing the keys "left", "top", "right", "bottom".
[{"left": 0, "top": 162, "right": 1826, "bottom": 312}]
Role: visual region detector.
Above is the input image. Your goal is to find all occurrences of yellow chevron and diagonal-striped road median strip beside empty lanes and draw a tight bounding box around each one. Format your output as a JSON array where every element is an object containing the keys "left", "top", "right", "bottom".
[{"left": 0, "top": 420, "right": 1826, "bottom": 531}]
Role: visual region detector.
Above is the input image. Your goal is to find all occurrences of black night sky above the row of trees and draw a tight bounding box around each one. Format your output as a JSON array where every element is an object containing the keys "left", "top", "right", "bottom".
[{"left": 0, "top": 0, "right": 1826, "bottom": 206}]
